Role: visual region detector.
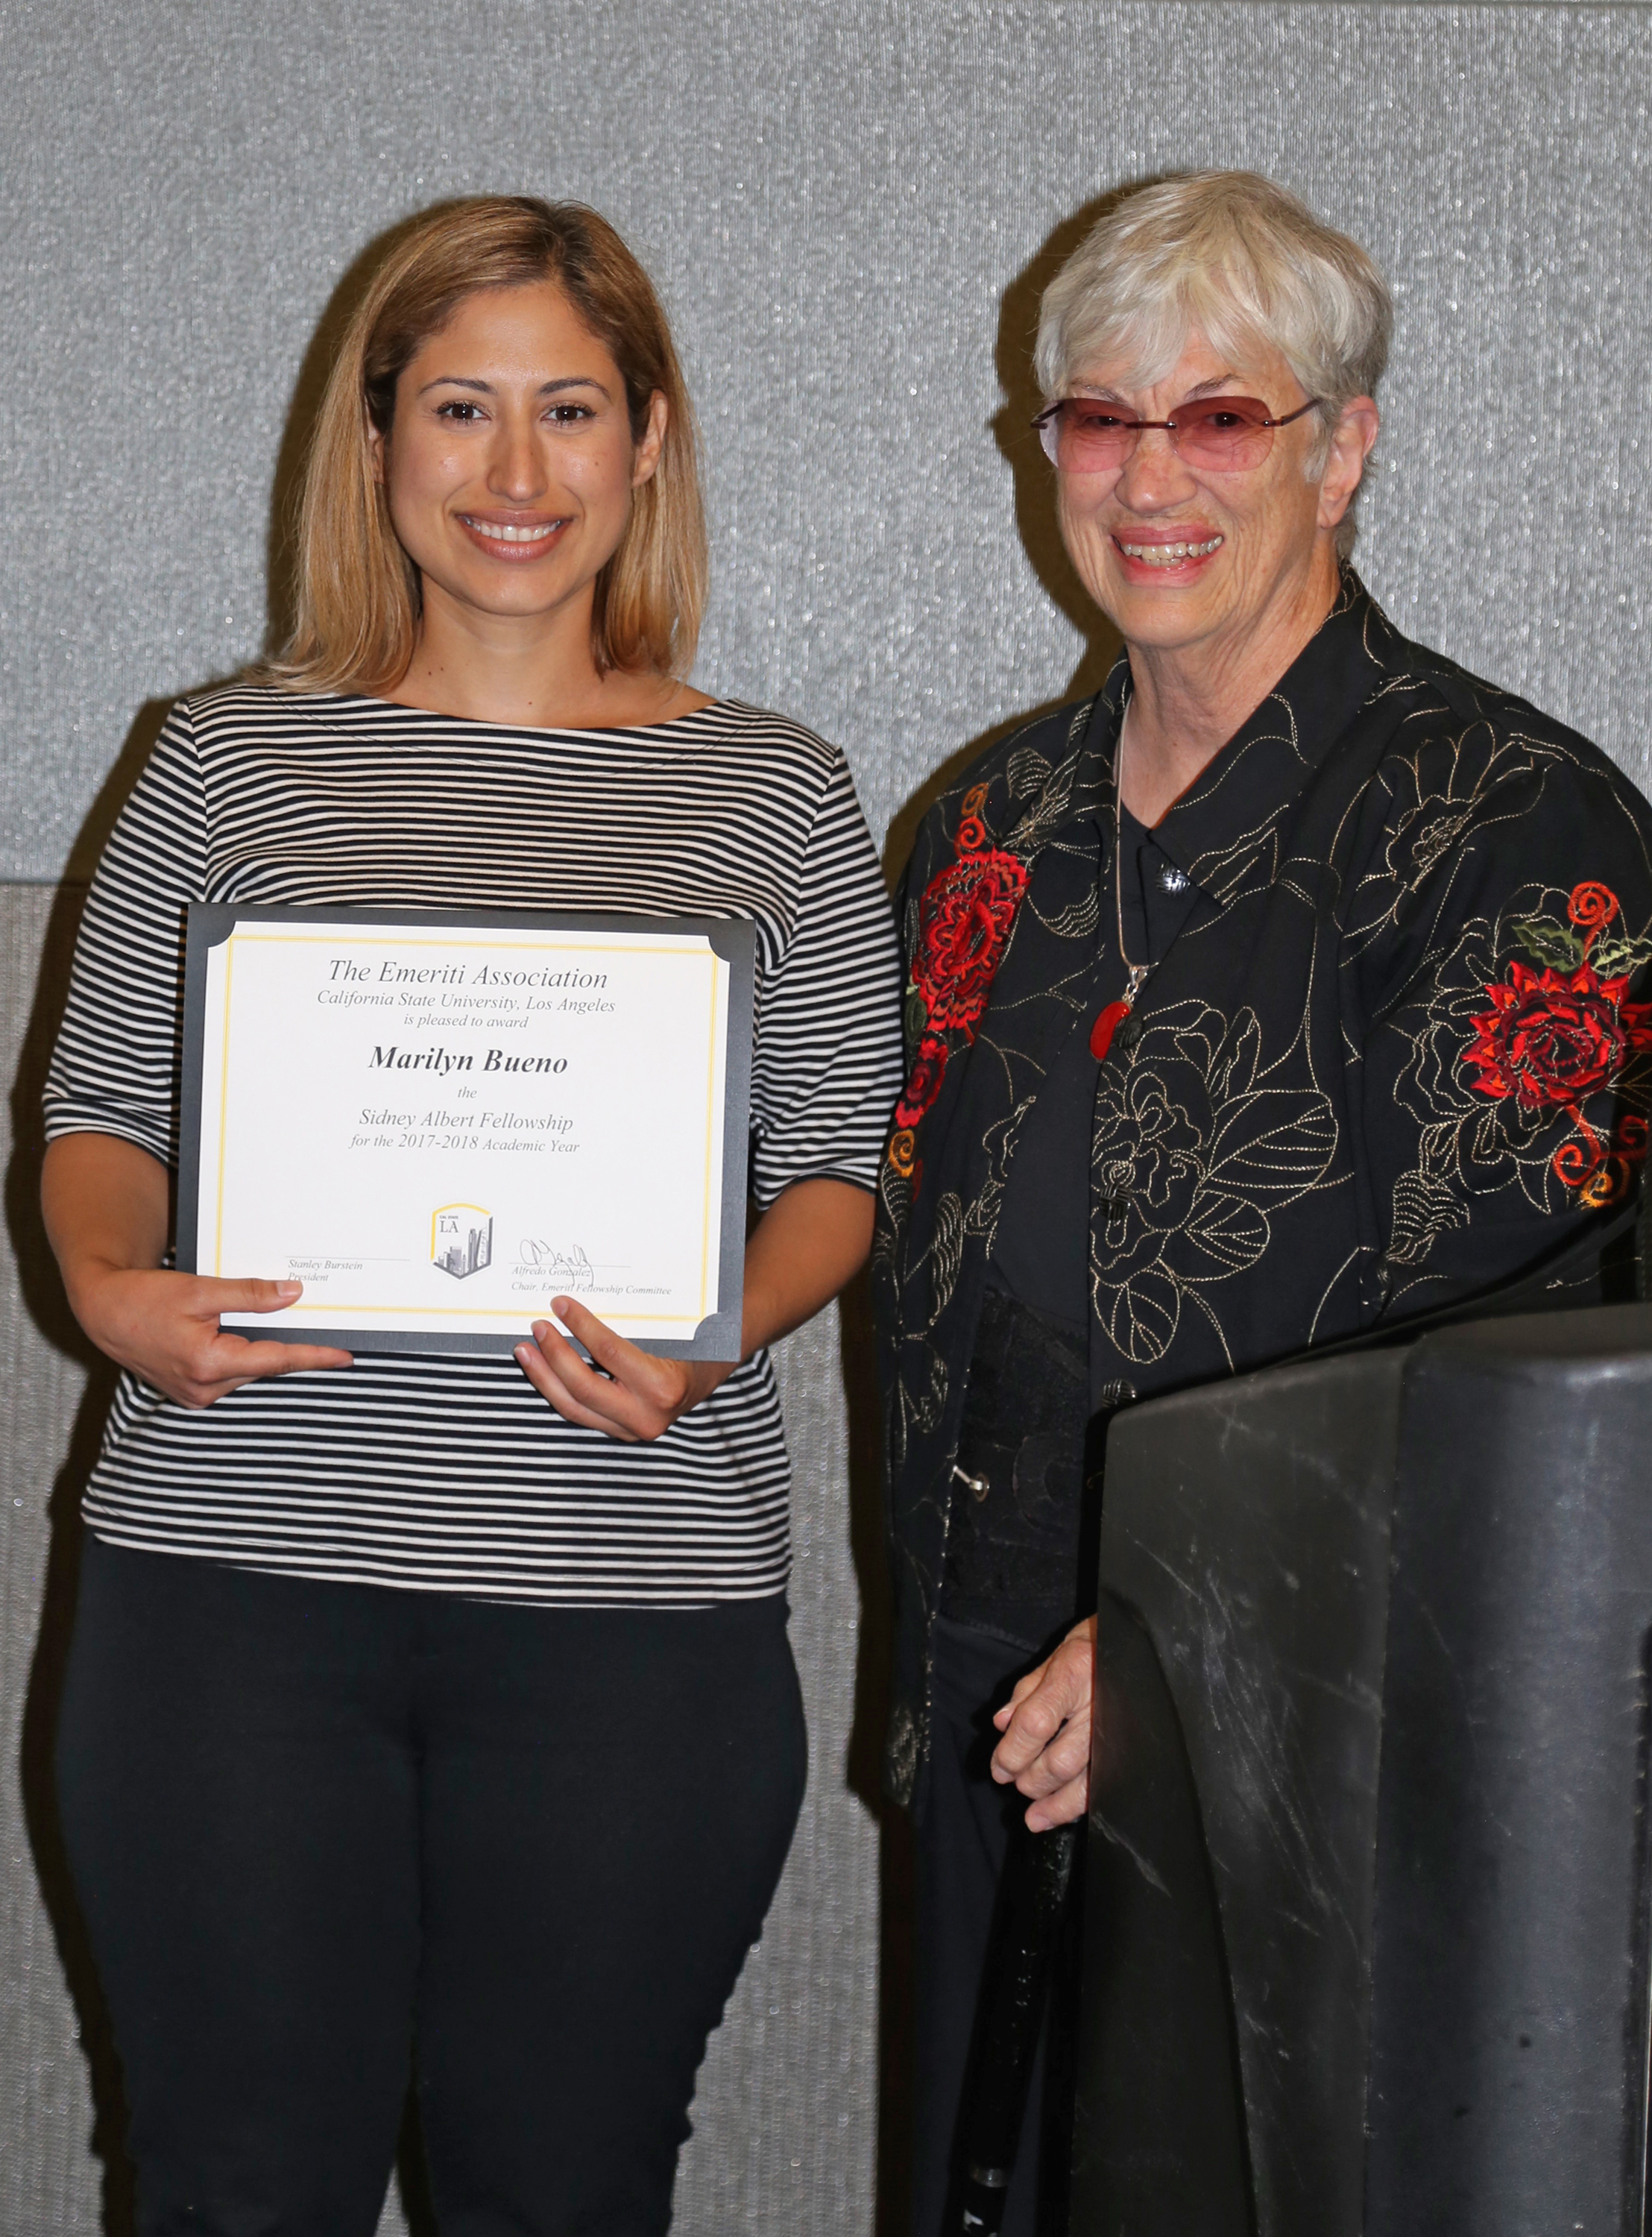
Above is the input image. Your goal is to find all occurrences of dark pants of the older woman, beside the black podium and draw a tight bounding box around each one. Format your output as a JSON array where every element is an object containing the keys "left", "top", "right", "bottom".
[{"left": 912, "top": 1620, "right": 1075, "bottom": 2237}]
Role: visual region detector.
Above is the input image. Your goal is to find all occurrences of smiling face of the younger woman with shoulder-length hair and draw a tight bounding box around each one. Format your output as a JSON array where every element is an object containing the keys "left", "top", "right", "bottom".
[{"left": 371, "top": 280, "right": 666, "bottom": 626}]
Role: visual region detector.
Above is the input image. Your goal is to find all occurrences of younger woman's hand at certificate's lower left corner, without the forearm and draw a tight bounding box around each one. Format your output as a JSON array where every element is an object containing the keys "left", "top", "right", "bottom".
[{"left": 69, "top": 1266, "right": 351, "bottom": 1407}]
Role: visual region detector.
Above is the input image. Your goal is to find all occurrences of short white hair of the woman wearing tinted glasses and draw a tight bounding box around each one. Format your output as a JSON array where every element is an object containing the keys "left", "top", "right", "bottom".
[{"left": 1032, "top": 170, "right": 1393, "bottom": 553}]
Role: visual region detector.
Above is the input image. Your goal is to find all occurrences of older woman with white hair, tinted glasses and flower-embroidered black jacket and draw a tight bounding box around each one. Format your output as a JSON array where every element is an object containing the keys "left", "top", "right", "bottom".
[{"left": 874, "top": 172, "right": 1652, "bottom": 2237}]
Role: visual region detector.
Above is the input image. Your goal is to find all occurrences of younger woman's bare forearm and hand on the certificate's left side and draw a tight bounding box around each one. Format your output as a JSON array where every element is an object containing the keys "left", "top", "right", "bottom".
[{"left": 40, "top": 1134, "right": 351, "bottom": 1407}]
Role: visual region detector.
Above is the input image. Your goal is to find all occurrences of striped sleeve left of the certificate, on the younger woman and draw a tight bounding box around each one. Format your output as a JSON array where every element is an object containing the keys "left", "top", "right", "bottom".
[{"left": 45, "top": 702, "right": 206, "bottom": 1165}]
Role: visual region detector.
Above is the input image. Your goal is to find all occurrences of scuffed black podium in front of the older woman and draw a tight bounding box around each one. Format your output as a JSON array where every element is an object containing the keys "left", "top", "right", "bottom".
[{"left": 1071, "top": 1304, "right": 1652, "bottom": 2237}]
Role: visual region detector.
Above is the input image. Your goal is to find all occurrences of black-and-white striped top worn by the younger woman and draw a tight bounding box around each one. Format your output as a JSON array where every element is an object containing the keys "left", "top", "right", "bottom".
[{"left": 47, "top": 685, "right": 901, "bottom": 1606}]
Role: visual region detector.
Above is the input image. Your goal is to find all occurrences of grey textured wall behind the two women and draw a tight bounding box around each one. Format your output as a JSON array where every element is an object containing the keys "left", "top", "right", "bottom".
[{"left": 0, "top": 0, "right": 1652, "bottom": 2237}]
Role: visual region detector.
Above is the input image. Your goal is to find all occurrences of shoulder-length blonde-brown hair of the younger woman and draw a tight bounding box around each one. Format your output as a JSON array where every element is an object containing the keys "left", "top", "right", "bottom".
[{"left": 264, "top": 195, "right": 707, "bottom": 693}]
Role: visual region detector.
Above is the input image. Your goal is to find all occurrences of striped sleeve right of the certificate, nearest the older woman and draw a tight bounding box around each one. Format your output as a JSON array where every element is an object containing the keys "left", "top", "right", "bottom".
[{"left": 751, "top": 754, "right": 901, "bottom": 1210}]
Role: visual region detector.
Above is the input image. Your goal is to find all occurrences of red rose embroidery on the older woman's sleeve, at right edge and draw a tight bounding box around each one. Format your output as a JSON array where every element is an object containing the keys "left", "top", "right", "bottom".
[{"left": 1462, "top": 881, "right": 1652, "bottom": 1204}]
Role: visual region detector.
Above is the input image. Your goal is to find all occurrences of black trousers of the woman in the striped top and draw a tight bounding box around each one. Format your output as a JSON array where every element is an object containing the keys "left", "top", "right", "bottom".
[{"left": 58, "top": 1539, "right": 805, "bottom": 2237}]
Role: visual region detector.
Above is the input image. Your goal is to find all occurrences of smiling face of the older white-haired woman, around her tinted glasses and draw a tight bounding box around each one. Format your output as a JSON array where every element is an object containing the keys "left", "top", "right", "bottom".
[{"left": 1057, "top": 333, "right": 1377, "bottom": 660}]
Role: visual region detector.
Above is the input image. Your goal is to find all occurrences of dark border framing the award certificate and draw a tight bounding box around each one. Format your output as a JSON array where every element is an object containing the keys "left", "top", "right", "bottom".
[{"left": 177, "top": 902, "right": 758, "bottom": 1360}]
